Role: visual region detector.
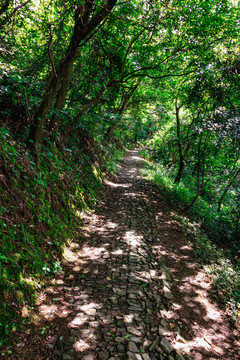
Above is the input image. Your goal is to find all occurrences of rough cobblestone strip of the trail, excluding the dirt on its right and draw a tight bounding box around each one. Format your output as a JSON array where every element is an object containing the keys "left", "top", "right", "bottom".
[{"left": 50, "top": 151, "right": 190, "bottom": 360}]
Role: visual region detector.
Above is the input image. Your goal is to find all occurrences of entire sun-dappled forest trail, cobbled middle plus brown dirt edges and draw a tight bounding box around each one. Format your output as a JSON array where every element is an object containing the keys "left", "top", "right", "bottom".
[{"left": 12, "top": 151, "right": 238, "bottom": 360}]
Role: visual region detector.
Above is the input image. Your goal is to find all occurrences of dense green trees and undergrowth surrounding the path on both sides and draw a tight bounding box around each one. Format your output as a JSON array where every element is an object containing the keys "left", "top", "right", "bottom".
[{"left": 0, "top": 0, "right": 240, "bottom": 348}]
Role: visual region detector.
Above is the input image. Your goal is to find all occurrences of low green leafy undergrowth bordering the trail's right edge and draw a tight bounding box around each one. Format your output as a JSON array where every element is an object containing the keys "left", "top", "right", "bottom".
[{"left": 142, "top": 155, "right": 240, "bottom": 326}]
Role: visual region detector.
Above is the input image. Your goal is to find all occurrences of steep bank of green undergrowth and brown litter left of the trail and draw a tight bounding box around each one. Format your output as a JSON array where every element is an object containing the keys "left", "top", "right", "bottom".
[{"left": 0, "top": 128, "right": 123, "bottom": 345}]
